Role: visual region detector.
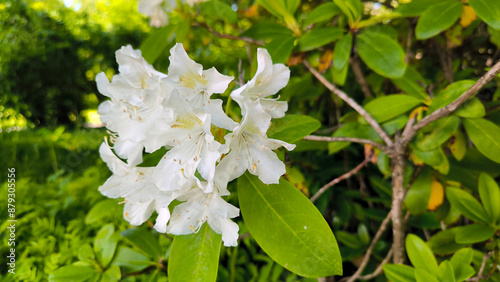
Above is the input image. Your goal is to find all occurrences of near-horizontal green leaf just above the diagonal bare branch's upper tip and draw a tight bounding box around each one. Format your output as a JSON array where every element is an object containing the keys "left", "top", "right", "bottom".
[{"left": 299, "top": 27, "right": 344, "bottom": 51}]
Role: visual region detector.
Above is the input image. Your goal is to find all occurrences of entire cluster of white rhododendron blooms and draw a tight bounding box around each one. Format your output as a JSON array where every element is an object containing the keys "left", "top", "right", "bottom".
[{"left": 96, "top": 44, "right": 295, "bottom": 246}]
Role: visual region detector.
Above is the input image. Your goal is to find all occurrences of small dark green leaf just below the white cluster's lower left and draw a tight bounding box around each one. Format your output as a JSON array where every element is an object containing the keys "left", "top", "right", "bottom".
[{"left": 121, "top": 227, "right": 163, "bottom": 259}]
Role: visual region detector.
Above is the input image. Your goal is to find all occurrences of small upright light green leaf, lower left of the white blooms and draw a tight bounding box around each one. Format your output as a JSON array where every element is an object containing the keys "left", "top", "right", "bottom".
[{"left": 94, "top": 223, "right": 118, "bottom": 266}]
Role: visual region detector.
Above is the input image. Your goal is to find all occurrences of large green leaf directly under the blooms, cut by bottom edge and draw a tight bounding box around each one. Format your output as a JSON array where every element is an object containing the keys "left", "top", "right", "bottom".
[{"left": 168, "top": 223, "right": 222, "bottom": 282}]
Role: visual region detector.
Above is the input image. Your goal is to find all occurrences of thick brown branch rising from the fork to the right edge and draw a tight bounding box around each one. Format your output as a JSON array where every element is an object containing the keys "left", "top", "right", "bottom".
[{"left": 401, "top": 61, "right": 500, "bottom": 145}]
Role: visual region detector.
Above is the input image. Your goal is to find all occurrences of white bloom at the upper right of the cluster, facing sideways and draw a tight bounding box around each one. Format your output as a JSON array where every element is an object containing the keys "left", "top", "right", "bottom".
[{"left": 231, "top": 48, "right": 290, "bottom": 118}]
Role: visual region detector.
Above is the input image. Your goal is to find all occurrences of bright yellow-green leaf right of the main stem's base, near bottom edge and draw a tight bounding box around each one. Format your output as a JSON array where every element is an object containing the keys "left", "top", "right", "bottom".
[{"left": 406, "top": 234, "right": 438, "bottom": 274}]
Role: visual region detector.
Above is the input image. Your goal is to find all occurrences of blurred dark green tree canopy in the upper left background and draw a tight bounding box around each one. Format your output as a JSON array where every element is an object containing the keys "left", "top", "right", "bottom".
[{"left": 0, "top": 0, "right": 149, "bottom": 126}]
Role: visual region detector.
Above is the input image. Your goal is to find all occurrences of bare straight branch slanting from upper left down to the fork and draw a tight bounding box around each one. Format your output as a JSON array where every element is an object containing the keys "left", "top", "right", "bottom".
[{"left": 303, "top": 60, "right": 393, "bottom": 146}]
